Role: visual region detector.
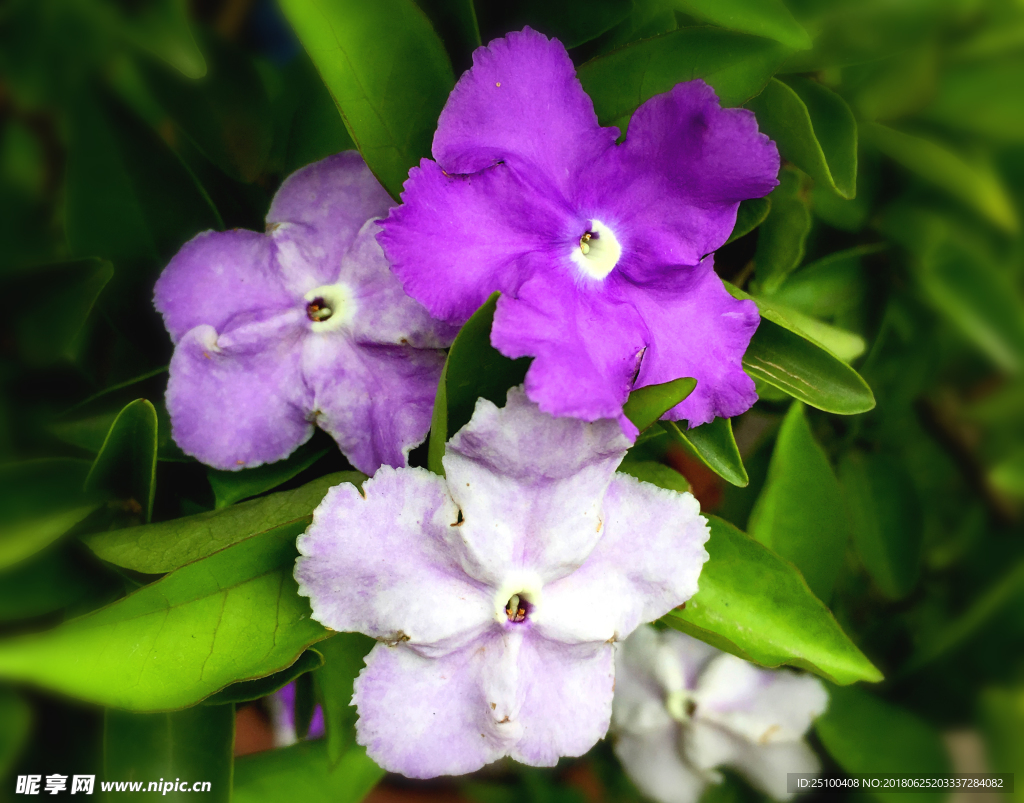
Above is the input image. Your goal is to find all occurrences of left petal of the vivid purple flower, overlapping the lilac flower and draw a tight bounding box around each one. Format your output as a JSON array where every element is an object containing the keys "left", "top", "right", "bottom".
[{"left": 378, "top": 159, "right": 568, "bottom": 325}]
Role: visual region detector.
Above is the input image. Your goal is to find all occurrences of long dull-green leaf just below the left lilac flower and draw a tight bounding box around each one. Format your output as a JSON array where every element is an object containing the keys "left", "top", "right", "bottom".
[{"left": 83, "top": 471, "right": 366, "bottom": 575}]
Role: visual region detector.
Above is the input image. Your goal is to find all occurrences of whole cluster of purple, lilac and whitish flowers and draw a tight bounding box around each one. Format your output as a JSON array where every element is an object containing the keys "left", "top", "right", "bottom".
[{"left": 156, "top": 29, "right": 802, "bottom": 782}]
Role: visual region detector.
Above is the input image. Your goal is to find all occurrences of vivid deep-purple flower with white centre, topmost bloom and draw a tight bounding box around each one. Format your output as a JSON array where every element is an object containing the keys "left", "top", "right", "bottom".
[{"left": 378, "top": 28, "right": 779, "bottom": 434}]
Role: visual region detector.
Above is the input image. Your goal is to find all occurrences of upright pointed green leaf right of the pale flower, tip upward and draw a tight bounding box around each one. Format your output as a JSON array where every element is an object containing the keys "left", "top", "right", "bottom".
[{"left": 750, "top": 402, "right": 850, "bottom": 602}]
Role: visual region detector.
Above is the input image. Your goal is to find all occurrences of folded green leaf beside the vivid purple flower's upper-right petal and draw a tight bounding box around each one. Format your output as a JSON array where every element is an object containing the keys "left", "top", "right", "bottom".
[{"left": 746, "top": 78, "right": 857, "bottom": 199}]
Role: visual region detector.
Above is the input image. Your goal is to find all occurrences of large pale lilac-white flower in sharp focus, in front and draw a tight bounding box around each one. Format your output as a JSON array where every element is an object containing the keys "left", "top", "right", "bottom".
[{"left": 295, "top": 388, "right": 709, "bottom": 777}]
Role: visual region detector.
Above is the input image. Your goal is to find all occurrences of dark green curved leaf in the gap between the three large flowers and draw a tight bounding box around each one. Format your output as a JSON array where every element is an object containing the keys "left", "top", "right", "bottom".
[{"left": 427, "top": 293, "right": 530, "bottom": 475}]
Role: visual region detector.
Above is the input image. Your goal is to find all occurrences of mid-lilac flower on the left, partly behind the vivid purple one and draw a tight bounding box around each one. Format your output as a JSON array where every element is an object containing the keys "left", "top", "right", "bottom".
[{"left": 155, "top": 152, "right": 455, "bottom": 473}]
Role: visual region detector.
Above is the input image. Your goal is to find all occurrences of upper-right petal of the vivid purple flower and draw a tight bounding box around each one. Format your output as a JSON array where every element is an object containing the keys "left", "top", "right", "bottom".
[{"left": 581, "top": 80, "right": 779, "bottom": 276}]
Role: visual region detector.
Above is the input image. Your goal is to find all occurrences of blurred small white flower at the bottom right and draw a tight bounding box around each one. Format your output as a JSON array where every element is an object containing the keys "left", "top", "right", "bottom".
[{"left": 611, "top": 627, "right": 828, "bottom": 803}]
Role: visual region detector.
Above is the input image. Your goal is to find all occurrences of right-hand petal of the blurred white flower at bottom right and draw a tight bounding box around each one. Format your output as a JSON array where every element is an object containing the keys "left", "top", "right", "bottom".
[{"left": 694, "top": 654, "right": 828, "bottom": 745}]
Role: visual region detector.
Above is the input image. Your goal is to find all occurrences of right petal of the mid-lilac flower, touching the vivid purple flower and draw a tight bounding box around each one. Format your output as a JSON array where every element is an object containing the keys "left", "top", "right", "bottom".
[{"left": 337, "top": 220, "right": 459, "bottom": 348}]
